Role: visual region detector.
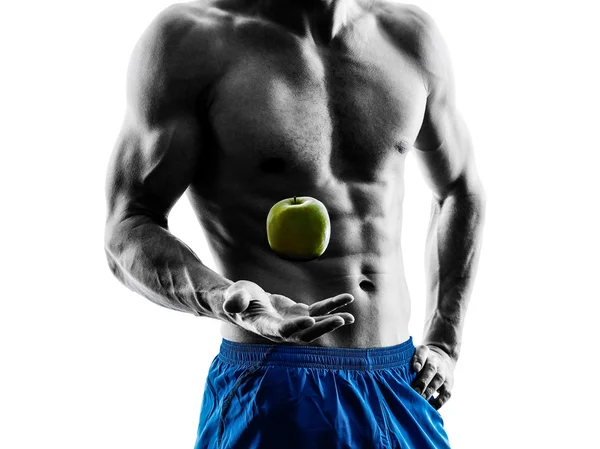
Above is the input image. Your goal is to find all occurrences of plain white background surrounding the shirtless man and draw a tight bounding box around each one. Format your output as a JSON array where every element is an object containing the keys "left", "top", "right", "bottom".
[{"left": 0, "top": 0, "right": 600, "bottom": 449}]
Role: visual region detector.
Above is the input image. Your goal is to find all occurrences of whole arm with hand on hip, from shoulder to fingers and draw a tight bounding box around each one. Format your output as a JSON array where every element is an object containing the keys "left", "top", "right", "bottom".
[{"left": 413, "top": 9, "right": 485, "bottom": 409}]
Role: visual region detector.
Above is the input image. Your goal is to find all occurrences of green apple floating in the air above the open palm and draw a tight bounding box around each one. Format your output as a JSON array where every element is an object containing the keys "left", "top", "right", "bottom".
[{"left": 267, "top": 196, "right": 331, "bottom": 260}]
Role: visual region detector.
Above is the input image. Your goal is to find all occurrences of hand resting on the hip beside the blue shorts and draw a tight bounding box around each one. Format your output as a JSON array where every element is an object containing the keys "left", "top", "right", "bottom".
[{"left": 411, "top": 345, "right": 456, "bottom": 410}]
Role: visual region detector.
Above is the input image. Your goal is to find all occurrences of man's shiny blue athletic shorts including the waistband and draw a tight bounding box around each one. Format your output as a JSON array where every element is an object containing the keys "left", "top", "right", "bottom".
[{"left": 195, "top": 337, "right": 450, "bottom": 449}]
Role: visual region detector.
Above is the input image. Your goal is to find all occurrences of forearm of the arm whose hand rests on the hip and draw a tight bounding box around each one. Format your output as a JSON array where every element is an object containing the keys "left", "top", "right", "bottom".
[{"left": 424, "top": 186, "right": 485, "bottom": 361}]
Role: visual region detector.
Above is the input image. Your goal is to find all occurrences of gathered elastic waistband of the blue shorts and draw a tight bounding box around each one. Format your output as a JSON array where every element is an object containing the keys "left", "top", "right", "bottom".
[{"left": 218, "top": 337, "right": 415, "bottom": 371}]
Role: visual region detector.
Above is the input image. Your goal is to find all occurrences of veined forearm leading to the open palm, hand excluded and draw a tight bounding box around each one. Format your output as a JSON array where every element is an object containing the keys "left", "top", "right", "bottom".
[{"left": 106, "top": 216, "right": 233, "bottom": 319}]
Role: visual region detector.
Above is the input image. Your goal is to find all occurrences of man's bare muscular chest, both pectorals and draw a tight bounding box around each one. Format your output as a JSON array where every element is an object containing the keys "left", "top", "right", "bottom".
[{"left": 205, "top": 19, "right": 425, "bottom": 181}]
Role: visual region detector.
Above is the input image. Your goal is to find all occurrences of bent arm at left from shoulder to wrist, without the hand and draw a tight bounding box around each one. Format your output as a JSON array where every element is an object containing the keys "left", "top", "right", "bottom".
[{"left": 105, "top": 8, "right": 233, "bottom": 320}]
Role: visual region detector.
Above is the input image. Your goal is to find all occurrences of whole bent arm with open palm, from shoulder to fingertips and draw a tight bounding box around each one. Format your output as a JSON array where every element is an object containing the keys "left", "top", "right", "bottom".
[{"left": 106, "top": 5, "right": 354, "bottom": 344}]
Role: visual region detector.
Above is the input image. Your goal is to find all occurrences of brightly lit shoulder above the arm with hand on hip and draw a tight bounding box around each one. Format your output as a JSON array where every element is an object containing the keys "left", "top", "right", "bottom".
[{"left": 374, "top": 0, "right": 450, "bottom": 87}]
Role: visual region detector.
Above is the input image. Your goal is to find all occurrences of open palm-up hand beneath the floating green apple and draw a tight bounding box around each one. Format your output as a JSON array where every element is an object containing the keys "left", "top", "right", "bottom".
[{"left": 223, "top": 281, "right": 354, "bottom": 344}]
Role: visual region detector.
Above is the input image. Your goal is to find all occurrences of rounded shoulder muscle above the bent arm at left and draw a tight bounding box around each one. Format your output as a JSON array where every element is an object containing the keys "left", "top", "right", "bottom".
[{"left": 127, "top": 0, "right": 231, "bottom": 113}]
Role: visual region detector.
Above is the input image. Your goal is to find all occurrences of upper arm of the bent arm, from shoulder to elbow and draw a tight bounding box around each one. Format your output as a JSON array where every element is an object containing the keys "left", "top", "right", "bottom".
[{"left": 107, "top": 12, "right": 203, "bottom": 226}]
